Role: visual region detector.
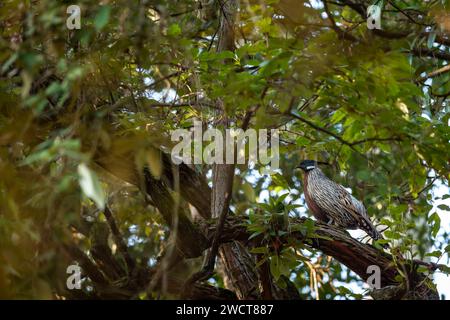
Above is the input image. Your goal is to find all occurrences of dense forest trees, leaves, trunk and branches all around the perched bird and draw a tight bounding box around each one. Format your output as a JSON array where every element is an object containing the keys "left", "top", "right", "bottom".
[{"left": 0, "top": 0, "right": 450, "bottom": 299}]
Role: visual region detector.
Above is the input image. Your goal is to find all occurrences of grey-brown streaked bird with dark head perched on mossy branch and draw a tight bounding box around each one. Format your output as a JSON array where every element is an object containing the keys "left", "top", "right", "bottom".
[{"left": 297, "top": 160, "right": 386, "bottom": 247}]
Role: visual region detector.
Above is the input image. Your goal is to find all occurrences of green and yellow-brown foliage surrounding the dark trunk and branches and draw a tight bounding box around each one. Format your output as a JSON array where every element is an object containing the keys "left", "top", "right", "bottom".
[{"left": 0, "top": 0, "right": 450, "bottom": 299}]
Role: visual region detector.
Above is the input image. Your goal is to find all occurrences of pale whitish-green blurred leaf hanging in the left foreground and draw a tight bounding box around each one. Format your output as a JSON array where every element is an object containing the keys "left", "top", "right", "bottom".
[{"left": 78, "top": 163, "right": 106, "bottom": 210}]
